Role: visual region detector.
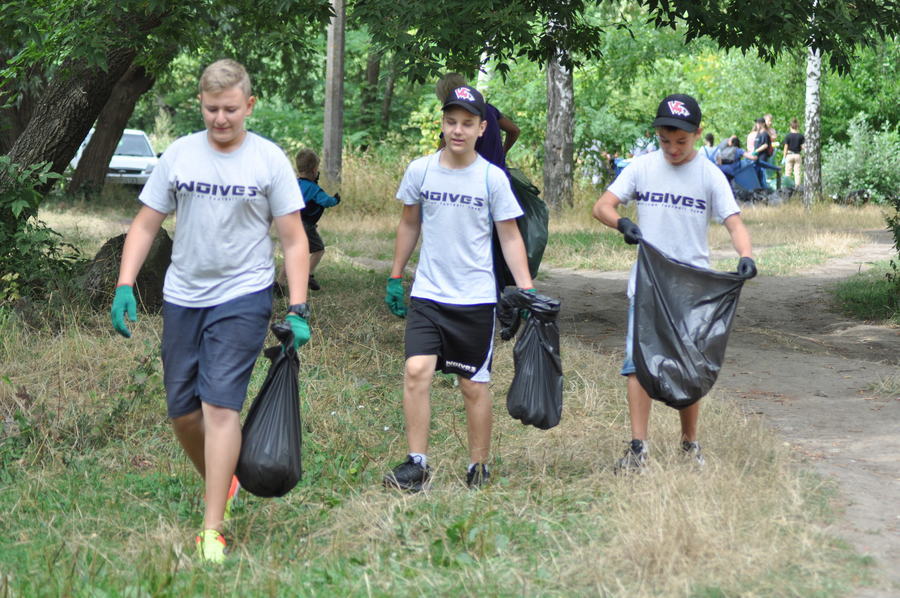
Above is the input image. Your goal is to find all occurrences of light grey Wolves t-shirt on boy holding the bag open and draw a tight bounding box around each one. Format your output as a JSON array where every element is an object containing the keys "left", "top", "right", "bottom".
[{"left": 608, "top": 152, "right": 741, "bottom": 297}]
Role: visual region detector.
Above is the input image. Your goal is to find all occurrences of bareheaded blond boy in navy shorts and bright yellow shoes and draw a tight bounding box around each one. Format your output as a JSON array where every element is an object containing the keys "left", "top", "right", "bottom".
[{"left": 111, "top": 60, "right": 310, "bottom": 563}]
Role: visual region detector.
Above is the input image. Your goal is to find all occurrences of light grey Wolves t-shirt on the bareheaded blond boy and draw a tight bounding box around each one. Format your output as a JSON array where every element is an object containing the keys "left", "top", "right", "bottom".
[{"left": 139, "top": 131, "right": 303, "bottom": 307}]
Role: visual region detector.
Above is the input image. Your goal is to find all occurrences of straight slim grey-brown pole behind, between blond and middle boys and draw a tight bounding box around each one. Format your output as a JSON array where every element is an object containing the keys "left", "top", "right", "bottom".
[{"left": 321, "top": 0, "right": 346, "bottom": 189}]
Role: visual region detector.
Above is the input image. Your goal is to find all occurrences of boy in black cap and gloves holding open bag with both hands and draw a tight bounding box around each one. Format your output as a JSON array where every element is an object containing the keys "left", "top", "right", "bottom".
[{"left": 593, "top": 94, "right": 756, "bottom": 472}]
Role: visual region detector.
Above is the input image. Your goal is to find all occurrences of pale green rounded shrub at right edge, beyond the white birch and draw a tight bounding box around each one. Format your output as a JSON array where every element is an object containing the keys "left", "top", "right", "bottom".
[{"left": 822, "top": 113, "right": 900, "bottom": 203}]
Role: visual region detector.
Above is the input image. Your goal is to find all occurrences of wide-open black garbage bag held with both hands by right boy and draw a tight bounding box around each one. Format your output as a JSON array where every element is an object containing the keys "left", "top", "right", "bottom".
[{"left": 633, "top": 241, "right": 744, "bottom": 409}]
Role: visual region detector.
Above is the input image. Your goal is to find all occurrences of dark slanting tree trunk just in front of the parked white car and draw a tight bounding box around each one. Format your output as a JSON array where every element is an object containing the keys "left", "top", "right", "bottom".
[{"left": 69, "top": 64, "right": 155, "bottom": 193}]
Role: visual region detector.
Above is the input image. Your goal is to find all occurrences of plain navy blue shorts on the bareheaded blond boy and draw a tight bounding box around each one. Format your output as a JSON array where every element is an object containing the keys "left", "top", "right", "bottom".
[{"left": 162, "top": 287, "right": 272, "bottom": 418}]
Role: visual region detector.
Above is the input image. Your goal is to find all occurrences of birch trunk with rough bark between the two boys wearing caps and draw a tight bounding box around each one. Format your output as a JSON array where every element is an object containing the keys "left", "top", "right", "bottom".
[{"left": 544, "top": 53, "right": 575, "bottom": 210}]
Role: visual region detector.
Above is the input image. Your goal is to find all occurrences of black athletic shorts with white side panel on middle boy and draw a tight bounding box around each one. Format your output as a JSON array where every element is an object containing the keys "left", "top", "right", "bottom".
[{"left": 406, "top": 297, "right": 495, "bottom": 382}]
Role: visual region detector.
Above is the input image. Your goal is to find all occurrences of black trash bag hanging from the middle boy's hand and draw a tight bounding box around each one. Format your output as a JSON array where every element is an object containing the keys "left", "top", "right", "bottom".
[{"left": 497, "top": 288, "right": 563, "bottom": 430}]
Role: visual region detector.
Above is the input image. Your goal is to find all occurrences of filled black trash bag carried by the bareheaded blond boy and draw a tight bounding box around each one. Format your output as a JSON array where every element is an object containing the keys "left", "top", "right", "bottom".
[{"left": 236, "top": 322, "right": 302, "bottom": 498}]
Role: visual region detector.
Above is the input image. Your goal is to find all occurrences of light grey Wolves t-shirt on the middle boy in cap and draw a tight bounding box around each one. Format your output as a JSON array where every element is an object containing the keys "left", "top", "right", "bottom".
[{"left": 397, "top": 152, "right": 522, "bottom": 305}]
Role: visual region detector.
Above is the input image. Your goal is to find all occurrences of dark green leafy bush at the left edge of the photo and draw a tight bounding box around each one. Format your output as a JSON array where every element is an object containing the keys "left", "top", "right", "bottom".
[{"left": 0, "top": 156, "right": 78, "bottom": 305}]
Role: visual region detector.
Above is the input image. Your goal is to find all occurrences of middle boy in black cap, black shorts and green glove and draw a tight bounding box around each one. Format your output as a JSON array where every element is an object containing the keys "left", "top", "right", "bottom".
[{"left": 384, "top": 86, "right": 533, "bottom": 492}]
